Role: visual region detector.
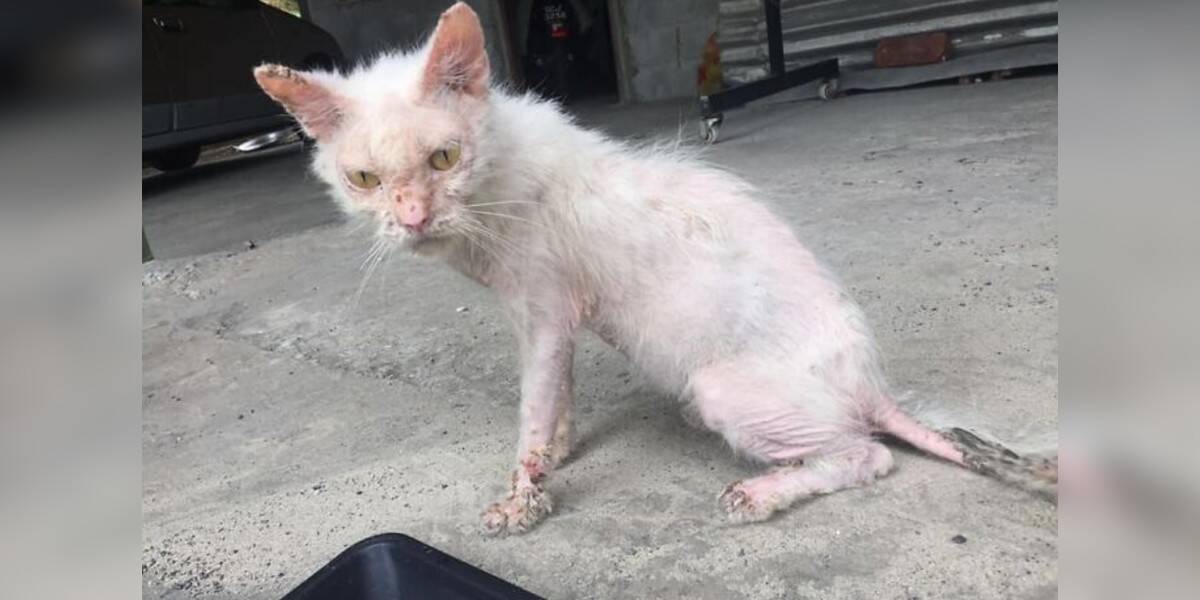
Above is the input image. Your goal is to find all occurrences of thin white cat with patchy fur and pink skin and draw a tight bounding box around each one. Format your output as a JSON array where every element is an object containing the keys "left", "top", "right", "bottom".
[{"left": 254, "top": 2, "right": 1057, "bottom": 534}]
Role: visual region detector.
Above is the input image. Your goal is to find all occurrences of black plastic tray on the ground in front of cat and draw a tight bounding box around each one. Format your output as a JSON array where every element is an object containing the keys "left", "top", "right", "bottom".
[{"left": 283, "top": 533, "right": 541, "bottom": 600}]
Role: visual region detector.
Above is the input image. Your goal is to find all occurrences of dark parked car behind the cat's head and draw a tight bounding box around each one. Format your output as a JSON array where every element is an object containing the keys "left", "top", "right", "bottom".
[{"left": 142, "top": 0, "right": 343, "bottom": 170}]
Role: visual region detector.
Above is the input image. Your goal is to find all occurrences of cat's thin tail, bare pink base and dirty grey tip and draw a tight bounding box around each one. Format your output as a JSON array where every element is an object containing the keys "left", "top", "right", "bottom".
[{"left": 877, "top": 398, "right": 1058, "bottom": 502}]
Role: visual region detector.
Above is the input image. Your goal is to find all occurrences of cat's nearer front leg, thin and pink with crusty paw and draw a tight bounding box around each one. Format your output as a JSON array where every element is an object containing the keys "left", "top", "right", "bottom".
[{"left": 484, "top": 328, "right": 575, "bottom": 535}]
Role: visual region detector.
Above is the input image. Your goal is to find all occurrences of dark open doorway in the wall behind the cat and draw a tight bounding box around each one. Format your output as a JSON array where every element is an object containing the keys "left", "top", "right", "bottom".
[{"left": 500, "top": 0, "right": 617, "bottom": 103}]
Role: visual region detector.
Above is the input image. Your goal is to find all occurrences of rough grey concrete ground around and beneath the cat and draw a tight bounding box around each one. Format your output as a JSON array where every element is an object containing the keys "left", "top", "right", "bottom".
[{"left": 142, "top": 77, "right": 1058, "bottom": 599}]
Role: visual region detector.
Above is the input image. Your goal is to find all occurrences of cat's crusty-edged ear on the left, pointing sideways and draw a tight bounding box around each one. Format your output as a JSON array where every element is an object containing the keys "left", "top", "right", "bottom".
[{"left": 254, "top": 65, "right": 342, "bottom": 140}]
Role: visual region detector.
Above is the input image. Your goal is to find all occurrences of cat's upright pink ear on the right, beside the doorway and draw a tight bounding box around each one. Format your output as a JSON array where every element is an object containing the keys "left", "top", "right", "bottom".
[{"left": 421, "top": 2, "right": 491, "bottom": 98}]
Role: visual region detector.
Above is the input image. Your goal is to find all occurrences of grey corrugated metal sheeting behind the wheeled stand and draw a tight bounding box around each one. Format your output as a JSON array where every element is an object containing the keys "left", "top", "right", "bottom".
[{"left": 718, "top": 0, "right": 1058, "bottom": 83}]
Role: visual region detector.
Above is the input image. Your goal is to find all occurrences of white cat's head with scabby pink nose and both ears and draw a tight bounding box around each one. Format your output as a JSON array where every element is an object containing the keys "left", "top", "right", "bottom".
[{"left": 254, "top": 2, "right": 488, "bottom": 247}]
